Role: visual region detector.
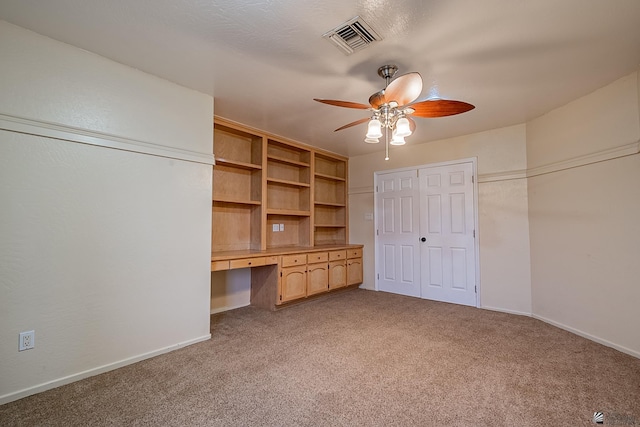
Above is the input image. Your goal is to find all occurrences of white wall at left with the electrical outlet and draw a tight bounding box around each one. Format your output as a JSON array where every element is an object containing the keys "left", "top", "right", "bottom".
[{"left": 0, "top": 21, "right": 213, "bottom": 404}]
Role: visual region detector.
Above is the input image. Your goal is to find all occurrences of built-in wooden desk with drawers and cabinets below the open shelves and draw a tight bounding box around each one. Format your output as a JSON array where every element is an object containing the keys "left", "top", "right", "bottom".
[{"left": 211, "top": 245, "right": 363, "bottom": 310}]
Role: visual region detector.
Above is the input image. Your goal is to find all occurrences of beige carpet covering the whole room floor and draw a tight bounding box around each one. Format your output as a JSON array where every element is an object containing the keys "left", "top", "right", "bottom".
[{"left": 0, "top": 290, "right": 640, "bottom": 427}]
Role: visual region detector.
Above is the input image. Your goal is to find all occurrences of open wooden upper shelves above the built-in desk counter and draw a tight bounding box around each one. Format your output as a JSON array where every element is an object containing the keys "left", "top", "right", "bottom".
[{"left": 212, "top": 117, "right": 348, "bottom": 253}]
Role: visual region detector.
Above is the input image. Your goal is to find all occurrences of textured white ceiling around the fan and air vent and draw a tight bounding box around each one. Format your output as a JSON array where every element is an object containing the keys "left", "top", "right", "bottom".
[{"left": 0, "top": 0, "right": 640, "bottom": 156}]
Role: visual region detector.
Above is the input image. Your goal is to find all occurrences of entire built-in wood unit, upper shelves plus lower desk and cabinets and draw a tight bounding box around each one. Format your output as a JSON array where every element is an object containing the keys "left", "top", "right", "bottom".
[{"left": 211, "top": 117, "right": 362, "bottom": 309}]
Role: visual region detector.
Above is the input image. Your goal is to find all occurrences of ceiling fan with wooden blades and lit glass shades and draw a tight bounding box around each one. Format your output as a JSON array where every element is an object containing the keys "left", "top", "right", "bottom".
[{"left": 314, "top": 65, "right": 475, "bottom": 160}]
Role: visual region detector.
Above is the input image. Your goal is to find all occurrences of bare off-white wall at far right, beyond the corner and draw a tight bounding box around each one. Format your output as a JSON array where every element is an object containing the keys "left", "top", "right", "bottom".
[{"left": 527, "top": 73, "right": 640, "bottom": 357}]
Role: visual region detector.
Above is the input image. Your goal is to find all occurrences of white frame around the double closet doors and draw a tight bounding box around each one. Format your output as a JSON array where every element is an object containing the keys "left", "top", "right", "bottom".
[{"left": 373, "top": 157, "right": 481, "bottom": 307}]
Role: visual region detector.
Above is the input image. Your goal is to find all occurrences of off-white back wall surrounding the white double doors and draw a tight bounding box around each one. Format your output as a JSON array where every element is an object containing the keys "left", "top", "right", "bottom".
[{"left": 349, "top": 123, "right": 531, "bottom": 314}]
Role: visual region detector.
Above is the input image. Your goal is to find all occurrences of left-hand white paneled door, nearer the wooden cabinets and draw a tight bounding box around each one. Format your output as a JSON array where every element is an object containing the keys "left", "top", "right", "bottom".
[{"left": 376, "top": 170, "right": 420, "bottom": 297}]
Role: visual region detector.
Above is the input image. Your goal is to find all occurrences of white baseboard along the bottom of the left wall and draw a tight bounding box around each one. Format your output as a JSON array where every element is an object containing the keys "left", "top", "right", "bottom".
[{"left": 0, "top": 334, "right": 211, "bottom": 405}]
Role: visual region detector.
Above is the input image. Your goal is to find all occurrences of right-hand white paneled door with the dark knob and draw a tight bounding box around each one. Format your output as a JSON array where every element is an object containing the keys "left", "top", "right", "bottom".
[{"left": 418, "top": 163, "right": 476, "bottom": 306}]
